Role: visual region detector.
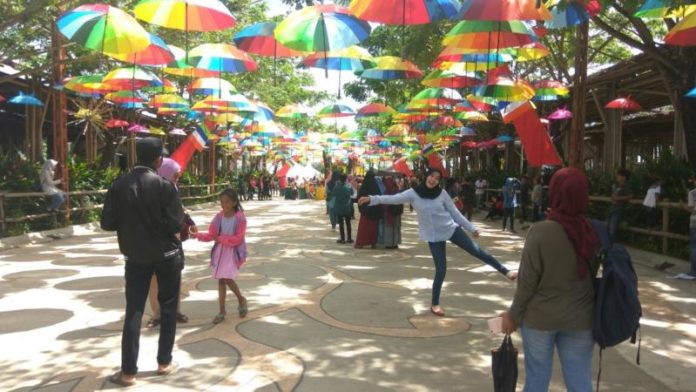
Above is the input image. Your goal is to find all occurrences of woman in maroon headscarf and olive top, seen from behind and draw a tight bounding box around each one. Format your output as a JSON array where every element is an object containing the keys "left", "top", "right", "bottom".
[{"left": 501, "top": 168, "right": 599, "bottom": 392}]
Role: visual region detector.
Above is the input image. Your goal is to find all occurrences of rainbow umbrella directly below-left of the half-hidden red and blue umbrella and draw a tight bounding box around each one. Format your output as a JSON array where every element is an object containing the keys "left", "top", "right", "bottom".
[{"left": 188, "top": 44, "right": 258, "bottom": 73}]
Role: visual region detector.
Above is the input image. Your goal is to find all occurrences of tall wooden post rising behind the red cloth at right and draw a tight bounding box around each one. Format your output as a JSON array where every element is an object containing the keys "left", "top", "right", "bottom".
[{"left": 568, "top": 21, "right": 589, "bottom": 170}]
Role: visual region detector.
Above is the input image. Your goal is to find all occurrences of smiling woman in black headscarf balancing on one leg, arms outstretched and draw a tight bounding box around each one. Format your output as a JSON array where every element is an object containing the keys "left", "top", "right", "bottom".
[{"left": 358, "top": 168, "right": 517, "bottom": 316}]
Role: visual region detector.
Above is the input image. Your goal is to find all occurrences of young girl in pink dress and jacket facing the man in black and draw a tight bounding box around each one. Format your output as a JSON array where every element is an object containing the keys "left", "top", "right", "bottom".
[{"left": 192, "top": 188, "right": 248, "bottom": 324}]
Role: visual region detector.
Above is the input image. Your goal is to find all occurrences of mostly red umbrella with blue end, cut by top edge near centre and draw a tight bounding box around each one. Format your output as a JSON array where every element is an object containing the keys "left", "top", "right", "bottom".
[{"left": 350, "top": 0, "right": 461, "bottom": 25}]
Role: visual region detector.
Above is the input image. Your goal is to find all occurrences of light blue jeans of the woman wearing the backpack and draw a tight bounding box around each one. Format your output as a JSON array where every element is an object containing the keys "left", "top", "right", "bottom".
[{"left": 522, "top": 325, "right": 594, "bottom": 392}]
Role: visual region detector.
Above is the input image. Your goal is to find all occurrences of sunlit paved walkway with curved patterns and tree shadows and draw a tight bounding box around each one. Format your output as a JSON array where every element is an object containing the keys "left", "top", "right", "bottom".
[{"left": 0, "top": 201, "right": 696, "bottom": 392}]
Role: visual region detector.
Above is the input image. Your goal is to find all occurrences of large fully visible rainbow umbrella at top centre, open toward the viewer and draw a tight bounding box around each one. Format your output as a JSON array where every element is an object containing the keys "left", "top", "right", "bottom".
[{"left": 274, "top": 4, "right": 370, "bottom": 52}]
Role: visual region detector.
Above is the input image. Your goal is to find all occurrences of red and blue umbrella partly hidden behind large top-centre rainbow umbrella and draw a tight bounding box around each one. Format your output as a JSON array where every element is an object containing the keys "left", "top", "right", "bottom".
[{"left": 234, "top": 22, "right": 304, "bottom": 57}]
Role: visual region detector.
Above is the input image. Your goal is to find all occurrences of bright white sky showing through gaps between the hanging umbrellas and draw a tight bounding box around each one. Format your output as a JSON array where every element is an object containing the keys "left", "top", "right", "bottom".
[{"left": 264, "top": 0, "right": 358, "bottom": 130}]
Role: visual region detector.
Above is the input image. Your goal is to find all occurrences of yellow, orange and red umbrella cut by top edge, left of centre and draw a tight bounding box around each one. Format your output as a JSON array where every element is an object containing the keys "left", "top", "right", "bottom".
[{"left": 135, "top": 0, "right": 236, "bottom": 31}]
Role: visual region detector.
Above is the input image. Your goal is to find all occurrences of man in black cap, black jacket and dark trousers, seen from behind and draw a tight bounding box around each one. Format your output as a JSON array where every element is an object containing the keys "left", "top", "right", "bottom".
[{"left": 101, "top": 137, "right": 184, "bottom": 386}]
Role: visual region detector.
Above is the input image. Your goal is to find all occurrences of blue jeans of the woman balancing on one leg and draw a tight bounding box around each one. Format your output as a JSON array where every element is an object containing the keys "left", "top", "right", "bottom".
[{"left": 428, "top": 227, "right": 509, "bottom": 306}]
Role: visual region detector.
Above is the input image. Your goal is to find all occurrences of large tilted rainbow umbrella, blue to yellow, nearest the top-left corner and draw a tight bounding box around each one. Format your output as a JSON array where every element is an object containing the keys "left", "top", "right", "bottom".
[{"left": 56, "top": 4, "right": 150, "bottom": 53}]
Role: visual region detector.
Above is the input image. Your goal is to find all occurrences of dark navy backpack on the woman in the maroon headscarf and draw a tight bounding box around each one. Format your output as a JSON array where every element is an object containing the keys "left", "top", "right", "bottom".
[{"left": 592, "top": 220, "right": 642, "bottom": 390}]
